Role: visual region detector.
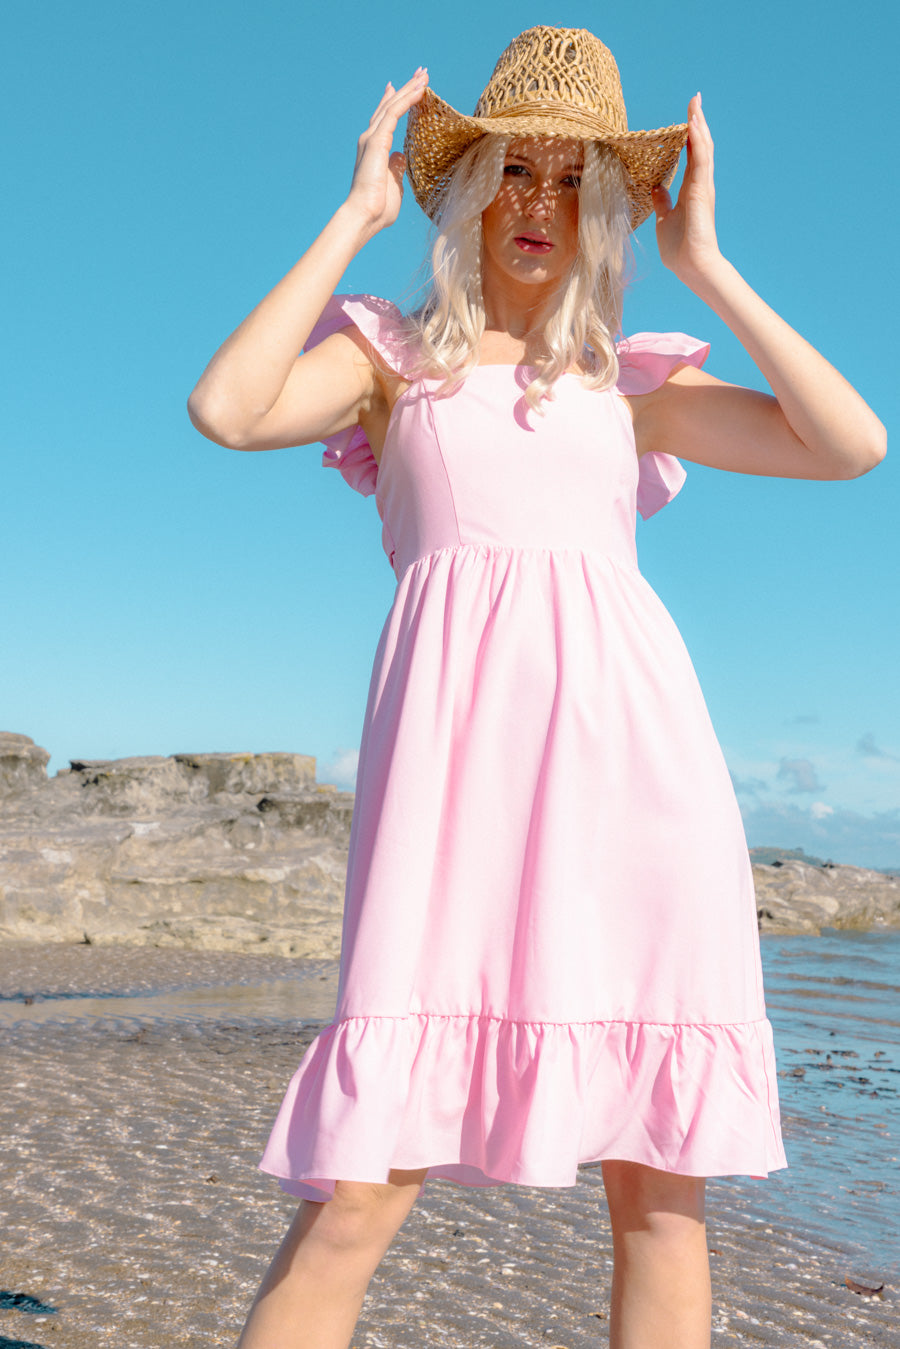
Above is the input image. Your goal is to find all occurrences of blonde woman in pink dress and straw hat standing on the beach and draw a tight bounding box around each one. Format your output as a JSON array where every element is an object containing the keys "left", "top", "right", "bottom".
[{"left": 190, "top": 28, "right": 884, "bottom": 1349}]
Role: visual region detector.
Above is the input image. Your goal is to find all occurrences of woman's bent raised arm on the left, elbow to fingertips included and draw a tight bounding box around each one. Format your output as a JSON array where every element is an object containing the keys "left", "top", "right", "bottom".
[{"left": 188, "top": 70, "right": 428, "bottom": 449}]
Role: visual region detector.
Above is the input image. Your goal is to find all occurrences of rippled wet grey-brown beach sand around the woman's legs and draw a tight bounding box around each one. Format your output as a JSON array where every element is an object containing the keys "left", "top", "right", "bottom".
[{"left": 0, "top": 947, "right": 900, "bottom": 1349}]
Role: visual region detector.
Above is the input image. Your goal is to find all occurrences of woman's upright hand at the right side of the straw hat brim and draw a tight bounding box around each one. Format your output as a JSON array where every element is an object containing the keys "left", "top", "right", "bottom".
[{"left": 653, "top": 93, "right": 721, "bottom": 286}]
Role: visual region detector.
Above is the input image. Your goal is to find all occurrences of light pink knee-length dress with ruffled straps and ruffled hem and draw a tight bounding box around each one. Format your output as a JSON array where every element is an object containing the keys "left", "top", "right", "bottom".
[{"left": 262, "top": 295, "right": 785, "bottom": 1199}]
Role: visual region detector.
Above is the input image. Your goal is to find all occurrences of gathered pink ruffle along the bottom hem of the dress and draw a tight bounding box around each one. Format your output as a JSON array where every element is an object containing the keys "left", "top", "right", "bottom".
[{"left": 260, "top": 1013, "right": 787, "bottom": 1201}]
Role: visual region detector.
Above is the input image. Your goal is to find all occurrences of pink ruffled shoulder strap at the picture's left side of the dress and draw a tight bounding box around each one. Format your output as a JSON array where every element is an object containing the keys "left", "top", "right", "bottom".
[{"left": 305, "top": 295, "right": 412, "bottom": 496}]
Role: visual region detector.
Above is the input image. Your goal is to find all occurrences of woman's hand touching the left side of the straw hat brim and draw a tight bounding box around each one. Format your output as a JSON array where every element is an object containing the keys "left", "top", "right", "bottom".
[{"left": 347, "top": 66, "right": 428, "bottom": 235}]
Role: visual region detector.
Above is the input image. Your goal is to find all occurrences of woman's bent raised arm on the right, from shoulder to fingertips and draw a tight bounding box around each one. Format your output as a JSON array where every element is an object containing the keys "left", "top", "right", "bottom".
[{"left": 631, "top": 94, "right": 887, "bottom": 479}]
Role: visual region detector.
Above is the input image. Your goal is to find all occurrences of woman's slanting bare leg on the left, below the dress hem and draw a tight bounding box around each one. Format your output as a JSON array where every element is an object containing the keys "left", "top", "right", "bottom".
[{"left": 237, "top": 1171, "right": 426, "bottom": 1349}]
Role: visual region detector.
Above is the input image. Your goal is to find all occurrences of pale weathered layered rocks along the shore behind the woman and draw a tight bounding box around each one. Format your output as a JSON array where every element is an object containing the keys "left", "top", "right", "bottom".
[{"left": 0, "top": 733, "right": 900, "bottom": 959}]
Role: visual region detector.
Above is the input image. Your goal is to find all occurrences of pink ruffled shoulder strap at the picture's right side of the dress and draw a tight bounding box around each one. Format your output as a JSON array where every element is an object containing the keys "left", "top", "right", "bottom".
[{"left": 615, "top": 333, "right": 710, "bottom": 519}]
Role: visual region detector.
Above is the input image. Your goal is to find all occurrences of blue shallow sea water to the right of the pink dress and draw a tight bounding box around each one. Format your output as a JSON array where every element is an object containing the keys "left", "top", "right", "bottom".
[{"left": 716, "top": 931, "right": 900, "bottom": 1282}]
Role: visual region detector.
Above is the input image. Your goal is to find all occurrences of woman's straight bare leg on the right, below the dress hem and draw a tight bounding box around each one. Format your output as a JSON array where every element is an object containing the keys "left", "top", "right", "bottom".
[{"left": 603, "top": 1161, "right": 711, "bottom": 1349}]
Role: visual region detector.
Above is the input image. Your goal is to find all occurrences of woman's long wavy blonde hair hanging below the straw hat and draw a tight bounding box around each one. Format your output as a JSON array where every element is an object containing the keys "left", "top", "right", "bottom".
[{"left": 406, "top": 136, "right": 631, "bottom": 411}]
